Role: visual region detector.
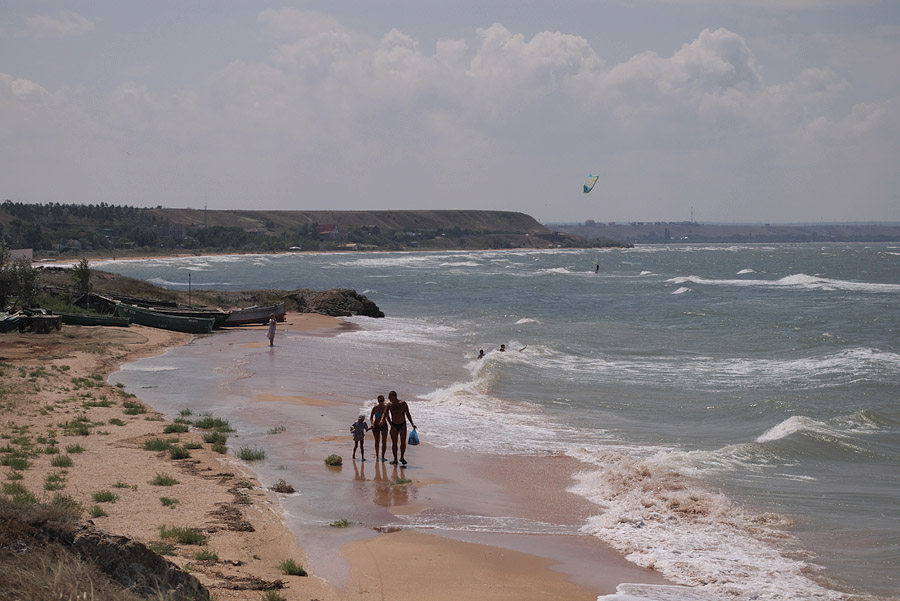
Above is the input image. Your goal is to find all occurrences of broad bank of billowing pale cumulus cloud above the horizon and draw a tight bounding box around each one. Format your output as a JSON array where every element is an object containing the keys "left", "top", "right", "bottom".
[{"left": 0, "top": 8, "right": 900, "bottom": 221}]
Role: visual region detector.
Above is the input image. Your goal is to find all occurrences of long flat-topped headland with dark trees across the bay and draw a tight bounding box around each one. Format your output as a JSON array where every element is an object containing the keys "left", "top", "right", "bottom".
[{"left": 0, "top": 201, "right": 623, "bottom": 257}]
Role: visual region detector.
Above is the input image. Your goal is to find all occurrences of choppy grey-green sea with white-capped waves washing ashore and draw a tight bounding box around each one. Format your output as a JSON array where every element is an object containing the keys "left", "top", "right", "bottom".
[{"left": 94, "top": 243, "right": 900, "bottom": 601}]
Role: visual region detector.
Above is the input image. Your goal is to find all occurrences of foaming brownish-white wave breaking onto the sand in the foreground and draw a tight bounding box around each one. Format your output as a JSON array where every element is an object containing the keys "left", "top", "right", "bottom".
[{"left": 571, "top": 449, "right": 843, "bottom": 601}]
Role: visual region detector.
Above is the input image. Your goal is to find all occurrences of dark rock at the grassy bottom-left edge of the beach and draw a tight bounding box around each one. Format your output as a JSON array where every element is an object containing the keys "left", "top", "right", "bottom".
[{"left": 72, "top": 524, "right": 209, "bottom": 601}]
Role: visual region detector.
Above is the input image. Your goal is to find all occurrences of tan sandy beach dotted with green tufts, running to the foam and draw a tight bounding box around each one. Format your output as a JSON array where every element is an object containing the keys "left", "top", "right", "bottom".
[{"left": 0, "top": 314, "right": 664, "bottom": 601}]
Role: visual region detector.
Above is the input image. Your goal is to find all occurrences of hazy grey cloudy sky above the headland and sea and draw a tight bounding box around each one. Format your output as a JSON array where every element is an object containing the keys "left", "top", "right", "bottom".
[{"left": 0, "top": 0, "right": 900, "bottom": 223}]
